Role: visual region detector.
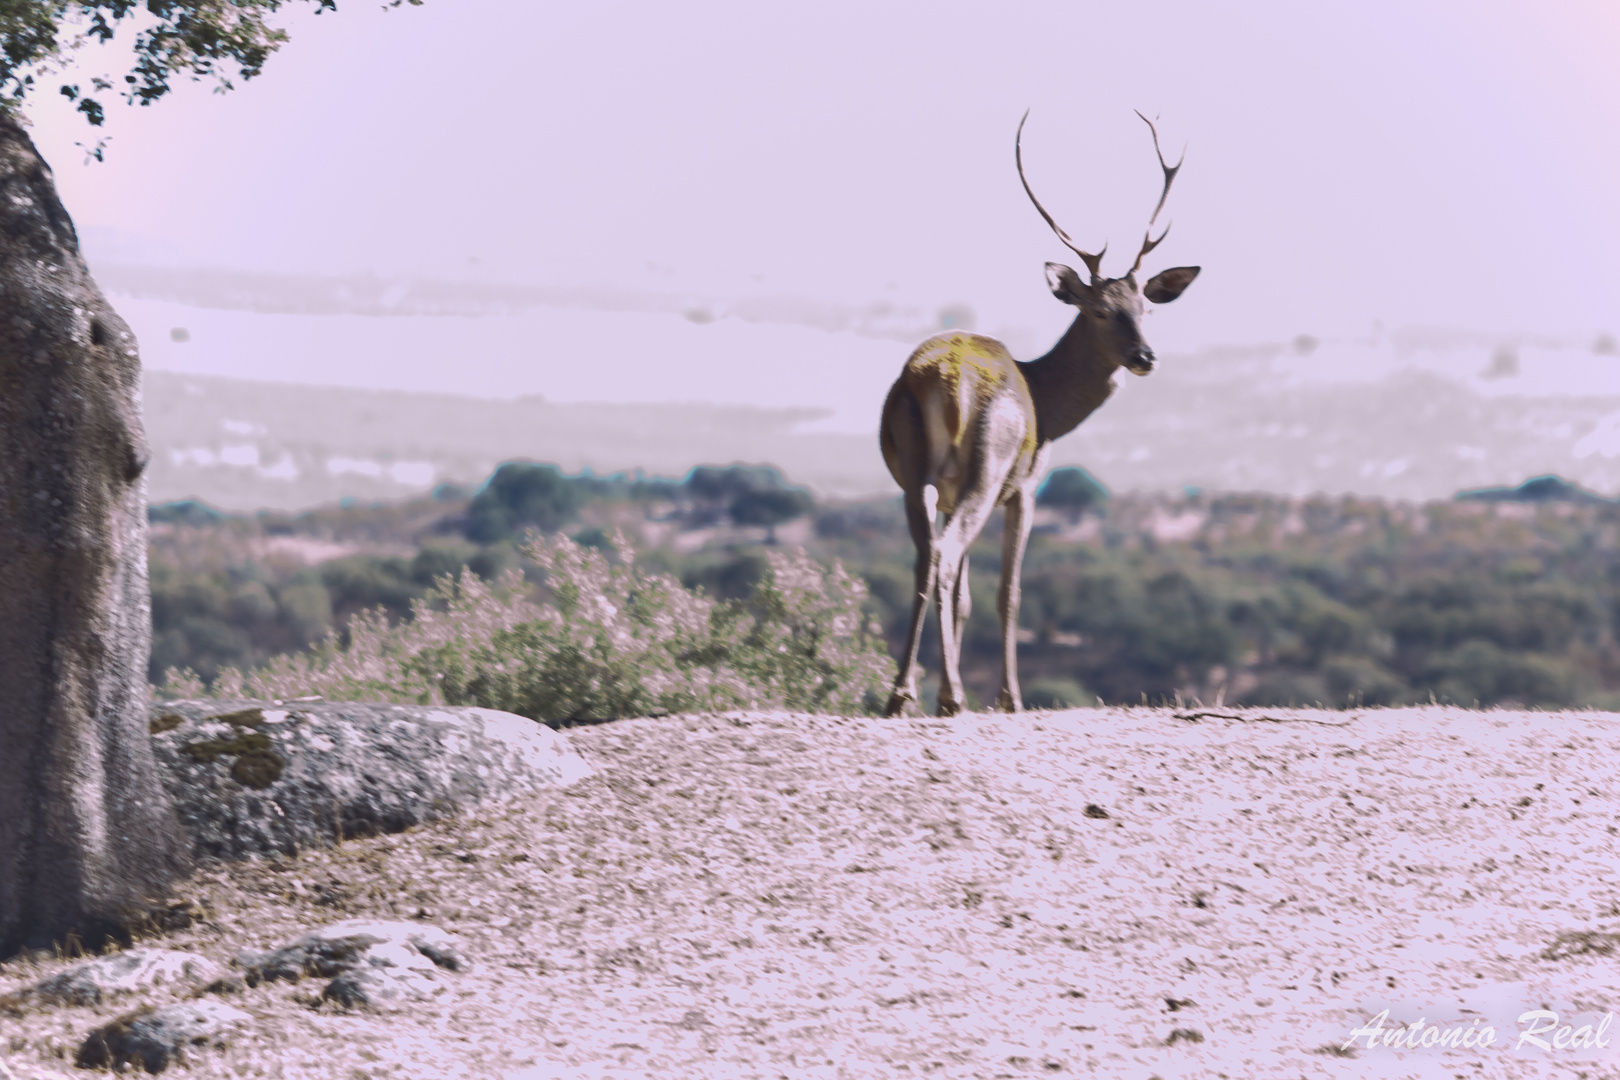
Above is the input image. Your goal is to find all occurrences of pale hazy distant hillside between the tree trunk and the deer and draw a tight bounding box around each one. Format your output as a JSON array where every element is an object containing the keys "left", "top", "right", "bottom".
[{"left": 144, "top": 371, "right": 893, "bottom": 510}]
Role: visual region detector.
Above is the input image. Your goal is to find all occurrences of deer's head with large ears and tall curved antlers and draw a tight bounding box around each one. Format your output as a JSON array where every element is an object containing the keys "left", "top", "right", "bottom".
[{"left": 1013, "top": 112, "right": 1202, "bottom": 376}]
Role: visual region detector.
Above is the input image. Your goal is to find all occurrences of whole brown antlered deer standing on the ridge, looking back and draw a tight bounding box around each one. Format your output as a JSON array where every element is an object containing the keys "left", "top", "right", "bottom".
[{"left": 881, "top": 112, "right": 1200, "bottom": 716}]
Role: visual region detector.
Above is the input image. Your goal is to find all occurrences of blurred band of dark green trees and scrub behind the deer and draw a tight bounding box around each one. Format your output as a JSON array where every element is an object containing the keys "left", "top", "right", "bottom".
[{"left": 152, "top": 465, "right": 1620, "bottom": 708}]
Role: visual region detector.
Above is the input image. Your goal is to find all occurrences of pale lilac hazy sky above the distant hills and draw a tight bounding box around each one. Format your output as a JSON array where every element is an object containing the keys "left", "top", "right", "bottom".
[{"left": 22, "top": 0, "right": 1620, "bottom": 410}]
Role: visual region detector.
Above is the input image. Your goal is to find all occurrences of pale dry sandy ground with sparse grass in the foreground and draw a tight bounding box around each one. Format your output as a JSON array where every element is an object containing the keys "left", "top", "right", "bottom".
[{"left": 0, "top": 708, "right": 1620, "bottom": 1080}]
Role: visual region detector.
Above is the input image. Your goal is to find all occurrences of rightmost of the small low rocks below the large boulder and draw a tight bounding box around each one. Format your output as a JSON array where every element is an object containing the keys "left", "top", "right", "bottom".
[{"left": 237, "top": 918, "right": 471, "bottom": 1009}]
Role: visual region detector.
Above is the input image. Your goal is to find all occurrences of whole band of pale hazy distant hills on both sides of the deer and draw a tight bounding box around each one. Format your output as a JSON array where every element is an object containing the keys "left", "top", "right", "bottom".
[{"left": 146, "top": 347, "right": 1620, "bottom": 510}]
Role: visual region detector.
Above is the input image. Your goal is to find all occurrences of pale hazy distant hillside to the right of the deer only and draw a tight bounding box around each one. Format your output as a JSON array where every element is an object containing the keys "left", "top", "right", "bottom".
[{"left": 1051, "top": 347, "right": 1620, "bottom": 500}]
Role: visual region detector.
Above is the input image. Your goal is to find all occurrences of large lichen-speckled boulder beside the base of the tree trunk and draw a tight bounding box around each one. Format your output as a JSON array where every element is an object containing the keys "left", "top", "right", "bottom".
[{"left": 149, "top": 701, "right": 591, "bottom": 858}]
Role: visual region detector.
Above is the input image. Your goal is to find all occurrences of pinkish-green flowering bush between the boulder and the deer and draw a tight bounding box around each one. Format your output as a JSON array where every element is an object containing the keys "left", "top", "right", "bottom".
[{"left": 160, "top": 533, "right": 894, "bottom": 721}]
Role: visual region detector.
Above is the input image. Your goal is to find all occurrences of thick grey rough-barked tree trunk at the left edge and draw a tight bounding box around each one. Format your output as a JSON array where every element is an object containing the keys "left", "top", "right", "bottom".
[{"left": 0, "top": 113, "right": 186, "bottom": 957}]
